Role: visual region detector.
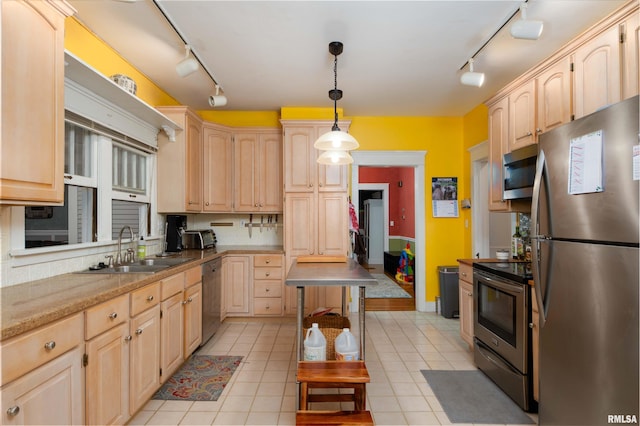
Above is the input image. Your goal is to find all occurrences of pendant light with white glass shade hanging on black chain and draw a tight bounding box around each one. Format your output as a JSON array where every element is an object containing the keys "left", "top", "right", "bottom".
[{"left": 313, "top": 41, "right": 360, "bottom": 157}]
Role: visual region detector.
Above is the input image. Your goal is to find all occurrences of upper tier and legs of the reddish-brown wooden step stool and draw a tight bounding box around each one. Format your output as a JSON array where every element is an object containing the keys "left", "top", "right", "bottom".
[{"left": 297, "top": 361, "right": 371, "bottom": 411}]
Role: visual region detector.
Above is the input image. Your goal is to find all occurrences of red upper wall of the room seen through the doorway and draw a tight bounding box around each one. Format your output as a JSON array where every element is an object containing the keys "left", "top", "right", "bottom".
[{"left": 358, "top": 167, "right": 416, "bottom": 238}]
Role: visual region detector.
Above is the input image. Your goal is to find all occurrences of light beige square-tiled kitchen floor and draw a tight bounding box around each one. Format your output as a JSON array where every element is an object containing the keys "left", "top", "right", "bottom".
[{"left": 130, "top": 311, "right": 537, "bottom": 425}]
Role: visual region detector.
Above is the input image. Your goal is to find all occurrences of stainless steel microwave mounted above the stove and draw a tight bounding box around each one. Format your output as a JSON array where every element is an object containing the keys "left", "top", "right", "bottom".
[{"left": 502, "top": 144, "right": 538, "bottom": 200}]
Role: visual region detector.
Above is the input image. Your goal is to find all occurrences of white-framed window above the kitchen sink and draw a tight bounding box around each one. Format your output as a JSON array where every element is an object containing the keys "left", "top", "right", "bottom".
[{"left": 24, "top": 116, "right": 155, "bottom": 248}]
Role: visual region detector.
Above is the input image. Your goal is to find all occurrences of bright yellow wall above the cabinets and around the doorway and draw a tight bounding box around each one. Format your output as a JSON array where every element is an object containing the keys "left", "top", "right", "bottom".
[{"left": 65, "top": 18, "right": 487, "bottom": 301}]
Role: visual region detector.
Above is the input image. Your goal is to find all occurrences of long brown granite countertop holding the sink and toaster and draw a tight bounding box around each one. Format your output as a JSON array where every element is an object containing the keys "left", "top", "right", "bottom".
[{"left": 0, "top": 245, "right": 284, "bottom": 340}]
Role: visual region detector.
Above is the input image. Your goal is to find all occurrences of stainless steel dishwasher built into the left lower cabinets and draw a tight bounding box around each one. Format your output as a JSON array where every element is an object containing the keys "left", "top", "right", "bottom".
[{"left": 201, "top": 258, "right": 222, "bottom": 346}]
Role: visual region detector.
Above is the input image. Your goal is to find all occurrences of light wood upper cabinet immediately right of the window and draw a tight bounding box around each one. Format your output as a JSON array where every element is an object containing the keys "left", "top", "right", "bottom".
[{"left": 157, "top": 106, "right": 203, "bottom": 213}]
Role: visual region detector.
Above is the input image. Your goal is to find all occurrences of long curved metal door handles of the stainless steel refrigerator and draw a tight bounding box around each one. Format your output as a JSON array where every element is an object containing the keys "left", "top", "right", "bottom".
[{"left": 531, "top": 150, "right": 551, "bottom": 327}]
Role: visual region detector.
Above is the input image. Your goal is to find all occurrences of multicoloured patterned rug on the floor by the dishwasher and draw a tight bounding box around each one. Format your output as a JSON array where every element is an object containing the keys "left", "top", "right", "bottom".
[{"left": 153, "top": 355, "right": 242, "bottom": 401}]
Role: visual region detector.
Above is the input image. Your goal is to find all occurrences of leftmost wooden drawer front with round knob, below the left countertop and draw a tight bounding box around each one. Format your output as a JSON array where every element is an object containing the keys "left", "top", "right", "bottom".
[{"left": 0, "top": 313, "right": 84, "bottom": 385}]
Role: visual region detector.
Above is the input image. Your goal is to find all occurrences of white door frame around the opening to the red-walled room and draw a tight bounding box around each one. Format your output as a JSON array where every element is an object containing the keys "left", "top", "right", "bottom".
[{"left": 350, "top": 151, "right": 427, "bottom": 312}]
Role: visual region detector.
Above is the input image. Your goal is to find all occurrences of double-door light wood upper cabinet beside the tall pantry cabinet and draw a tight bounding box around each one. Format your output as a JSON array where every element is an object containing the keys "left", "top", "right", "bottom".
[{"left": 234, "top": 130, "right": 282, "bottom": 213}]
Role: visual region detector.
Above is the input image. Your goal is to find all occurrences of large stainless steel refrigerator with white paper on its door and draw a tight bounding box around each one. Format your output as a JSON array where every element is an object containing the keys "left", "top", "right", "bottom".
[{"left": 532, "top": 96, "right": 640, "bottom": 425}]
